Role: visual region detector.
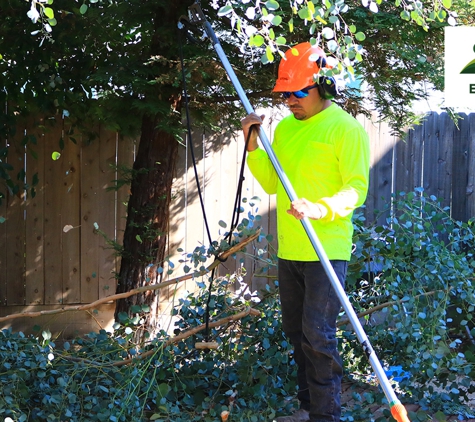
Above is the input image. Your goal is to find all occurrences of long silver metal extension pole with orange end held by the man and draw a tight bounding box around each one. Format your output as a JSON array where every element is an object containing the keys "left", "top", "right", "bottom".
[{"left": 189, "top": 3, "right": 410, "bottom": 422}]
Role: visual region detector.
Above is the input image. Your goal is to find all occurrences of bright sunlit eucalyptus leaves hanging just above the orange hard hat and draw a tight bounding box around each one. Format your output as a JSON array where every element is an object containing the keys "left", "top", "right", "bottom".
[{"left": 213, "top": 0, "right": 457, "bottom": 78}]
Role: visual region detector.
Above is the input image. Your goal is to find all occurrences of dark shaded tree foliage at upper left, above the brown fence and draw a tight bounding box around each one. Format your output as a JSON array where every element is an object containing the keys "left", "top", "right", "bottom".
[{"left": 0, "top": 0, "right": 271, "bottom": 203}]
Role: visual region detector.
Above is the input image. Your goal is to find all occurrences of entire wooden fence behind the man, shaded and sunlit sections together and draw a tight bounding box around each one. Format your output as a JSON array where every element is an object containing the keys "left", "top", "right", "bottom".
[{"left": 0, "top": 113, "right": 475, "bottom": 332}]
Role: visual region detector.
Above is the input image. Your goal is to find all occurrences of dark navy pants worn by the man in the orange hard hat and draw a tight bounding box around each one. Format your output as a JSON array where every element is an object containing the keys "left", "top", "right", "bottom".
[{"left": 278, "top": 259, "right": 348, "bottom": 422}]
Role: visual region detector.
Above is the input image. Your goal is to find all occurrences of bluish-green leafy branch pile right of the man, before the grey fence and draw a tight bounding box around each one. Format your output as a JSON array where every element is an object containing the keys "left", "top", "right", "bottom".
[{"left": 343, "top": 189, "right": 475, "bottom": 404}]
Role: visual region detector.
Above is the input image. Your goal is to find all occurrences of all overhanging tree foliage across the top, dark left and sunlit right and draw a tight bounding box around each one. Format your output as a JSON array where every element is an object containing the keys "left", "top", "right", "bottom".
[{"left": 0, "top": 0, "right": 474, "bottom": 138}]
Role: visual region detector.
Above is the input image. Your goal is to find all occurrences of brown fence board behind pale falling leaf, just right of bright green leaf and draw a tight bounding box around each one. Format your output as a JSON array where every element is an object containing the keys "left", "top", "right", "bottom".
[{"left": 59, "top": 124, "right": 81, "bottom": 304}]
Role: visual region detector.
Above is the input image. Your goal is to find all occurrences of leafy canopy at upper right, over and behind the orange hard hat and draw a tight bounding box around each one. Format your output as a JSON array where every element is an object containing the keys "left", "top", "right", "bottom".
[{"left": 214, "top": 0, "right": 475, "bottom": 133}]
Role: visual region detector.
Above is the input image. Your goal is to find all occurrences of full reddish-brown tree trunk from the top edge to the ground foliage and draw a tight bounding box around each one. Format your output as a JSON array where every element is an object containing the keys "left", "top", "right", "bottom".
[{"left": 115, "top": 0, "right": 193, "bottom": 332}]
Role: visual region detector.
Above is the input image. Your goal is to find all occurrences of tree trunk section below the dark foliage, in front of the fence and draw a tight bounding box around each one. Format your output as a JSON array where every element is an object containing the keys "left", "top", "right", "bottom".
[{"left": 115, "top": 116, "right": 178, "bottom": 323}]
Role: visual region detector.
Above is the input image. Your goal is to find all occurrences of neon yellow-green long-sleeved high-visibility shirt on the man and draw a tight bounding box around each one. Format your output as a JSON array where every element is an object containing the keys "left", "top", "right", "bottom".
[{"left": 247, "top": 103, "right": 370, "bottom": 261}]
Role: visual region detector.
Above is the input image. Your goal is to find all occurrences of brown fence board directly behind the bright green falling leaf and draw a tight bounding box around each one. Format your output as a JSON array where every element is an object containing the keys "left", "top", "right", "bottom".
[{"left": 43, "top": 124, "right": 67, "bottom": 305}]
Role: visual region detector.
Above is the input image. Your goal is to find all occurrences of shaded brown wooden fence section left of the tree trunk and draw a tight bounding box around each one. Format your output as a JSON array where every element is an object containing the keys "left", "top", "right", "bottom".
[{"left": 0, "top": 120, "right": 134, "bottom": 332}]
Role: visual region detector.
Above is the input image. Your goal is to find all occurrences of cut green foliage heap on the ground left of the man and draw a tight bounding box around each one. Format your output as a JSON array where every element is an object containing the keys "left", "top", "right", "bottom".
[{"left": 0, "top": 278, "right": 295, "bottom": 422}]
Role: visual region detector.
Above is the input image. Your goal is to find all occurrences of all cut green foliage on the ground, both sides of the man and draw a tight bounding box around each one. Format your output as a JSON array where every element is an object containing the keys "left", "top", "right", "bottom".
[{"left": 0, "top": 190, "right": 475, "bottom": 422}]
